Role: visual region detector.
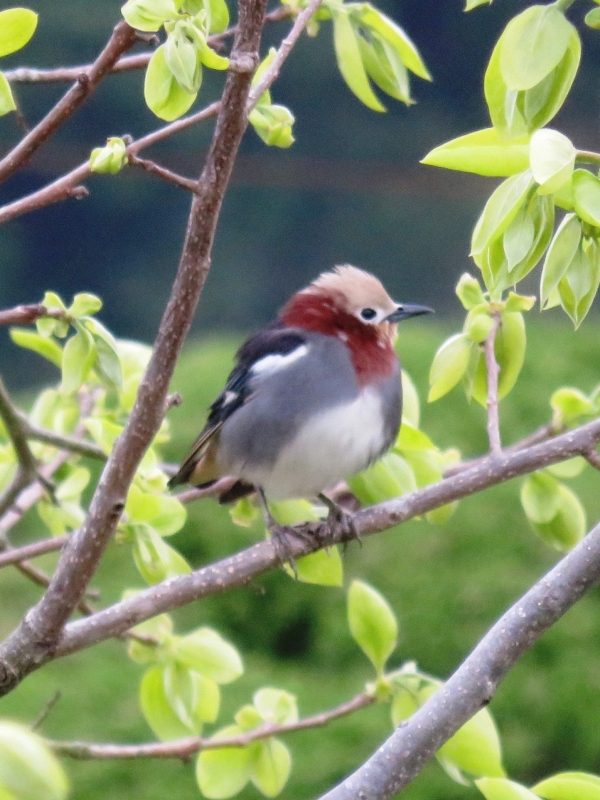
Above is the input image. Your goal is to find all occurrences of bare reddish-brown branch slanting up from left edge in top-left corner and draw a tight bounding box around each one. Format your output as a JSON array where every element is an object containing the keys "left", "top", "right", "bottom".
[{"left": 0, "top": 21, "right": 136, "bottom": 183}]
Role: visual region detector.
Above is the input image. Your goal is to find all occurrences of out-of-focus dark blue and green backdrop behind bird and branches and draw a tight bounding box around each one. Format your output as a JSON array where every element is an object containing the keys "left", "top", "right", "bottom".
[{"left": 0, "top": 0, "right": 600, "bottom": 800}]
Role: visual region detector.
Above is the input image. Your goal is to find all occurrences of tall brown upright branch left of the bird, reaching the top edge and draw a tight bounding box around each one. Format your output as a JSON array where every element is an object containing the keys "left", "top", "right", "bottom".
[{"left": 0, "top": 0, "right": 266, "bottom": 694}]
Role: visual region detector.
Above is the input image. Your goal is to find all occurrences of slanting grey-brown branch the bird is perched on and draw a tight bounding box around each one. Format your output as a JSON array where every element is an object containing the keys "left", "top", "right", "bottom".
[{"left": 55, "top": 420, "right": 600, "bottom": 656}]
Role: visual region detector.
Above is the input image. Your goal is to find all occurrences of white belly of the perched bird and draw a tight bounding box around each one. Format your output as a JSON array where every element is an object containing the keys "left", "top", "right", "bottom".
[{"left": 240, "top": 389, "right": 385, "bottom": 500}]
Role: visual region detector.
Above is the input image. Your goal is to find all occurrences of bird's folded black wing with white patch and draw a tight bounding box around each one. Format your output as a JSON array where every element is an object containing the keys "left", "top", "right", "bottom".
[{"left": 169, "top": 323, "right": 306, "bottom": 488}]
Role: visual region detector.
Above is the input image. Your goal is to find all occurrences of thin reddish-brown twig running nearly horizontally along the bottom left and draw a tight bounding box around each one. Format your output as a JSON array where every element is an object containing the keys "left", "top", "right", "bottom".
[{"left": 46, "top": 694, "right": 375, "bottom": 759}]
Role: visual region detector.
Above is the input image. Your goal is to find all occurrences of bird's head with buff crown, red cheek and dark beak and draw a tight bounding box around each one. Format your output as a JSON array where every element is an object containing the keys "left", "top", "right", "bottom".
[{"left": 280, "top": 265, "right": 431, "bottom": 342}]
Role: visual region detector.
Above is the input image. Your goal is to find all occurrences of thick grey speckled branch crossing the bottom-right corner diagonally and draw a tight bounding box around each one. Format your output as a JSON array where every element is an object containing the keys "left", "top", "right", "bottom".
[{"left": 323, "top": 525, "right": 600, "bottom": 800}]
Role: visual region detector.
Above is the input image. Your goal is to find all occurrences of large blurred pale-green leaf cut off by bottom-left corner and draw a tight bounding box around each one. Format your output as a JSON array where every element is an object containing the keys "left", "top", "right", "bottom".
[{"left": 0, "top": 720, "right": 69, "bottom": 800}]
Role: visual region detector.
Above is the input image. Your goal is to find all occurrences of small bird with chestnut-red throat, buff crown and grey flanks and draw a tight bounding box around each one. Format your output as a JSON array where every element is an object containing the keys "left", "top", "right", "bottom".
[{"left": 169, "top": 266, "right": 431, "bottom": 548}]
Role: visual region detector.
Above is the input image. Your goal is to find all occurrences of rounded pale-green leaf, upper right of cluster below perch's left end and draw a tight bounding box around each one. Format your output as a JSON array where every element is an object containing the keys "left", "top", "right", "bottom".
[{"left": 173, "top": 628, "right": 244, "bottom": 683}]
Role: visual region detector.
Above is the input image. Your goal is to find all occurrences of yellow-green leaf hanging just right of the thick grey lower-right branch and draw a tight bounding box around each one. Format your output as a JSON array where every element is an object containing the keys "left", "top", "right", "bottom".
[{"left": 437, "top": 708, "right": 506, "bottom": 778}]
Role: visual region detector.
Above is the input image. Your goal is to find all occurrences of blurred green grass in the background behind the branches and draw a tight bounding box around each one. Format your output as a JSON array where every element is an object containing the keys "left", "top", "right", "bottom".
[{"left": 0, "top": 319, "right": 600, "bottom": 800}]
